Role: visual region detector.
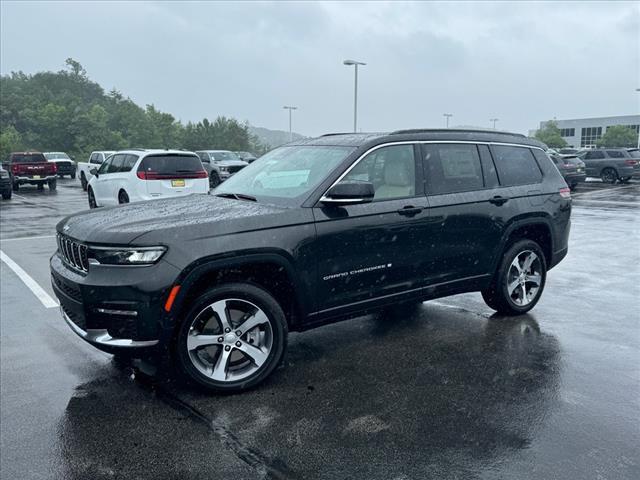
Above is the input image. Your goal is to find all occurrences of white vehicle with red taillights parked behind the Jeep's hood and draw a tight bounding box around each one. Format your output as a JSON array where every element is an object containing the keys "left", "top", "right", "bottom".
[{"left": 87, "top": 150, "right": 209, "bottom": 208}]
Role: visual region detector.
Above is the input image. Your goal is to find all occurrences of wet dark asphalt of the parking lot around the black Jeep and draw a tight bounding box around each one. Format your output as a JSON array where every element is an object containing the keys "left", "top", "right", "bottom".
[{"left": 0, "top": 180, "right": 640, "bottom": 480}]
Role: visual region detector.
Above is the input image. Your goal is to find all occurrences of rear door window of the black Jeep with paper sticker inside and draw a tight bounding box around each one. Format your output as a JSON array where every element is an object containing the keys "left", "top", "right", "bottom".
[{"left": 424, "top": 143, "right": 484, "bottom": 195}]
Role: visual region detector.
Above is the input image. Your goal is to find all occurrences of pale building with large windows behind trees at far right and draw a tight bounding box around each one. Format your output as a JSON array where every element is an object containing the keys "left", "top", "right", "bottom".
[{"left": 530, "top": 115, "right": 640, "bottom": 148}]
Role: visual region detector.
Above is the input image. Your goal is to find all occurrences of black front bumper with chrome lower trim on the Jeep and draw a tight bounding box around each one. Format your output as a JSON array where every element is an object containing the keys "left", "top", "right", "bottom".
[{"left": 50, "top": 253, "right": 179, "bottom": 353}]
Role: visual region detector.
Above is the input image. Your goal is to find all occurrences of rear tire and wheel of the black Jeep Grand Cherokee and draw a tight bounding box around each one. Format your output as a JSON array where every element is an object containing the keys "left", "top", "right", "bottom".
[{"left": 482, "top": 240, "right": 547, "bottom": 315}]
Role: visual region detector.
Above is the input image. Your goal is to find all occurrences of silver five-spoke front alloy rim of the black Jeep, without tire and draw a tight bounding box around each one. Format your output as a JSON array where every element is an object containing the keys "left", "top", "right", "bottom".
[{"left": 186, "top": 298, "right": 273, "bottom": 382}]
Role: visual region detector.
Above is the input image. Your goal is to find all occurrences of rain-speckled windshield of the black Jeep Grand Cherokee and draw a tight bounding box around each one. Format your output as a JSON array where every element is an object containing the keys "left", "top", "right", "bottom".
[{"left": 215, "top": 145, "right": 354, "bottom": 205}]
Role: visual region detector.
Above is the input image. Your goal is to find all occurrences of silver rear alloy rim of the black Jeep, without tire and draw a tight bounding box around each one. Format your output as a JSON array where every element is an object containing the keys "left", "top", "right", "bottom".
[{"left": 507, "top": 250, "right": 542, "bottom": 307}]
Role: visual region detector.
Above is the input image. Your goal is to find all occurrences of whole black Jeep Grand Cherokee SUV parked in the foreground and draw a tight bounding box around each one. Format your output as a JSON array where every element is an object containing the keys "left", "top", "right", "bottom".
[{"left": 51, "top": 130, "right": 571, "bottom": 391}]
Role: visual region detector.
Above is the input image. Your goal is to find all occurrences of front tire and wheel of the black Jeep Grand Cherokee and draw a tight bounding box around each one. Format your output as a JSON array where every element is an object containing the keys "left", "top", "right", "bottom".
[{"left": 173, "top": 283, "right": 288, "bottom": 393}]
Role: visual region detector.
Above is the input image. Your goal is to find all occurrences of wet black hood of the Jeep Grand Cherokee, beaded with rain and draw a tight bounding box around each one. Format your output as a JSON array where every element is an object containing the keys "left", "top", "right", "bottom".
[{"left": 56, "top": 195, "right": 301, "bottom": 245}]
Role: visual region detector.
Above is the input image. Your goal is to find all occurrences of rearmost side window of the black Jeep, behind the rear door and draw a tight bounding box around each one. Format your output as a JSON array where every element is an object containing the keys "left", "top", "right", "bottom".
[{"left": 491, "top": 145, "right": 542, "bottom": 187}]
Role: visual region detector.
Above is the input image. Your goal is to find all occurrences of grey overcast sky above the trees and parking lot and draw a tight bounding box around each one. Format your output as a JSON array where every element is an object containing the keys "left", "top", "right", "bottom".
[{"left": 0, "top": 0, "right": 640, "bottom": 135}]
